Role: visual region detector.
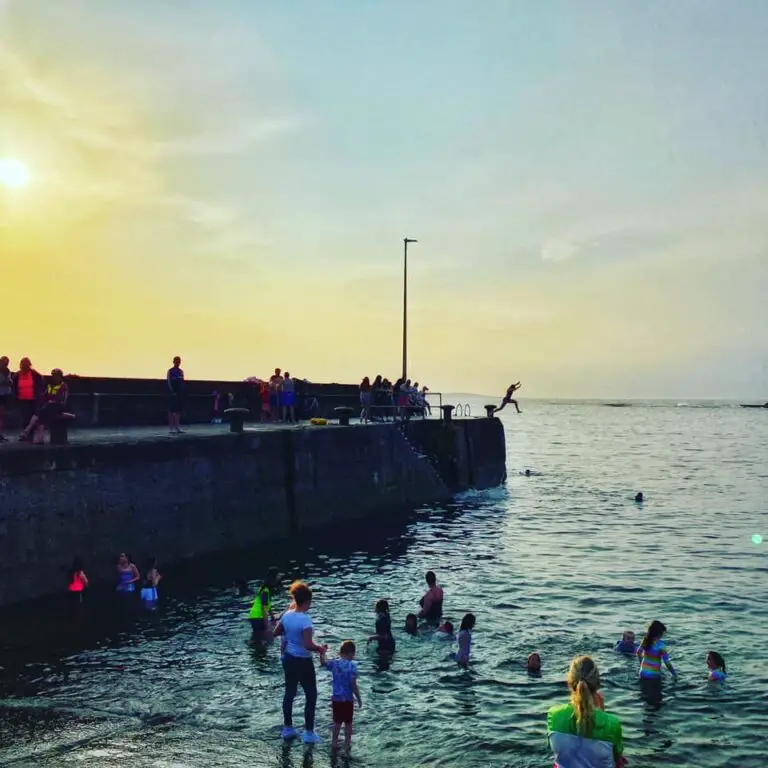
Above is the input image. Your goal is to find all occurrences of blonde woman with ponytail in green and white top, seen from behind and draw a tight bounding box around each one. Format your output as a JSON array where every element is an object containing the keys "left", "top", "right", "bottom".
[{"left": 547, "top": 656, "right": 625, "bottom": 768}]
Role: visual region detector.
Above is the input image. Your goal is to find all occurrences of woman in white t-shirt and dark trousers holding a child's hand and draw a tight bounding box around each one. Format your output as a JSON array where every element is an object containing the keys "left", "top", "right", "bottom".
[{"left": 274, "top": 582, "right": 328, "bottom": 744}]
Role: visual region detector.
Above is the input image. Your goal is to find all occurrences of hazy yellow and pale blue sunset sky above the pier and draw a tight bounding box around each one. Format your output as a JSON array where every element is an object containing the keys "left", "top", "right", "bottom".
[{"left": 0, "top": 0, "right": 768, "bottom": 400}]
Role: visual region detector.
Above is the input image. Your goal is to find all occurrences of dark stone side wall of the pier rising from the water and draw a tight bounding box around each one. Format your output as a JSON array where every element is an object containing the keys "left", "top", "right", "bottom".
[{"left": 0, "top": 419, "right": 506, "bottom": 605}]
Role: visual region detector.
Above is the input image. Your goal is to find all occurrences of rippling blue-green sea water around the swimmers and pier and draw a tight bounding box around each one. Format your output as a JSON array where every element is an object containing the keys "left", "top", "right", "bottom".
[{"left": 0, "top": 400, "right": 768, "bottom": 768}]
